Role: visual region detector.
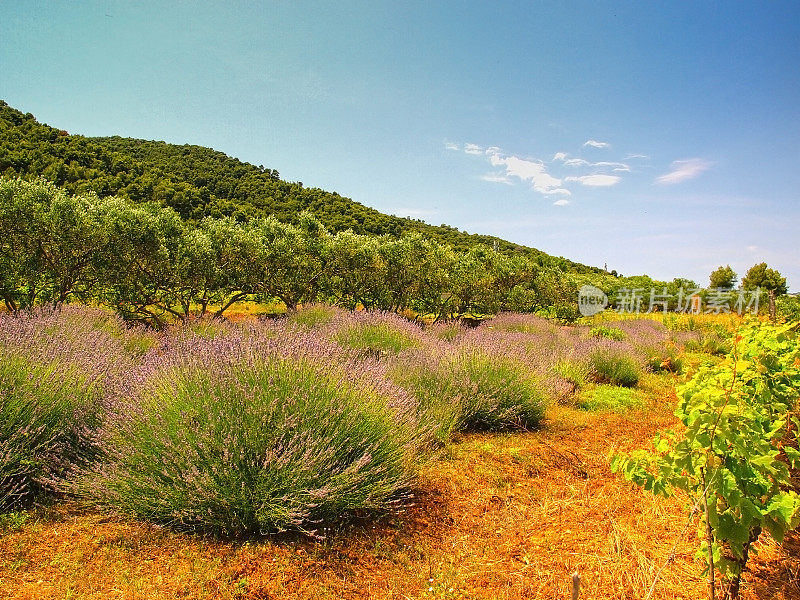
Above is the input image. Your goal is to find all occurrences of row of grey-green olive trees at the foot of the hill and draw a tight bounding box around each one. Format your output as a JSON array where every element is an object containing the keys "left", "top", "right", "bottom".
[{"left": 0, "top": 177, "right": 588, "bottom": 327}]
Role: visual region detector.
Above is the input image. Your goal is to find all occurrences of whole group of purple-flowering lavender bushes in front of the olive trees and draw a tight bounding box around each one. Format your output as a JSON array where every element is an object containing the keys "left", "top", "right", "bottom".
[{"left": 0, "top": 305, "right": 691, "bottom": 536}]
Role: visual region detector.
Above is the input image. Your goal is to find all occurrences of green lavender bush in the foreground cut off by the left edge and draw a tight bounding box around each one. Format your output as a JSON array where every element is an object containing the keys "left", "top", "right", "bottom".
[{"left": 0, "top": 348, "right": 100, "bottom": 509}]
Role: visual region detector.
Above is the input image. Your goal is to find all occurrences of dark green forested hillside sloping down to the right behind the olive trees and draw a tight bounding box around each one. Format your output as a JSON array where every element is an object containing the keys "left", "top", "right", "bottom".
[{"left": 0, "top": 100, "right": 599, "bottom": 272}]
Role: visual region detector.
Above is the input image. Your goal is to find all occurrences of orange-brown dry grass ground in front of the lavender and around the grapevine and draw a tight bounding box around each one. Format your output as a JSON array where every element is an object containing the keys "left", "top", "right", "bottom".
[{"left": 0, "top": 382, "right": 800, "bottom": 600}]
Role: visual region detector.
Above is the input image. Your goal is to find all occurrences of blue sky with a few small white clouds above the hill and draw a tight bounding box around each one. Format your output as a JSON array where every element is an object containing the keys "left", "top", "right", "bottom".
[{"left": 0, "top": 0, "right": 800, "bottom": 290}]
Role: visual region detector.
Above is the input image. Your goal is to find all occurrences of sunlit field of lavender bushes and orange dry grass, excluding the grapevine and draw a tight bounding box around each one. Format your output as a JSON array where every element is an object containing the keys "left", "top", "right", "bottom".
[{"left": 0, "top": 304, "right": 800, "bottom": 599}]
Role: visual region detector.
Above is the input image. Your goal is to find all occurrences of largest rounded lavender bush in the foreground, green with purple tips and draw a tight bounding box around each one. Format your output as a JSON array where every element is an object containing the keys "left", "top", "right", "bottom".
[{"left": 81, "top": 352, "right": 418, "bottom": 536}]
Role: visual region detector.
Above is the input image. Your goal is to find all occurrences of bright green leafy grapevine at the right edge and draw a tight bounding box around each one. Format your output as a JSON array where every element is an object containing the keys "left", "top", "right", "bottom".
[{"left": 612, "top": 319, "right": 800, "bottom": 600}]
